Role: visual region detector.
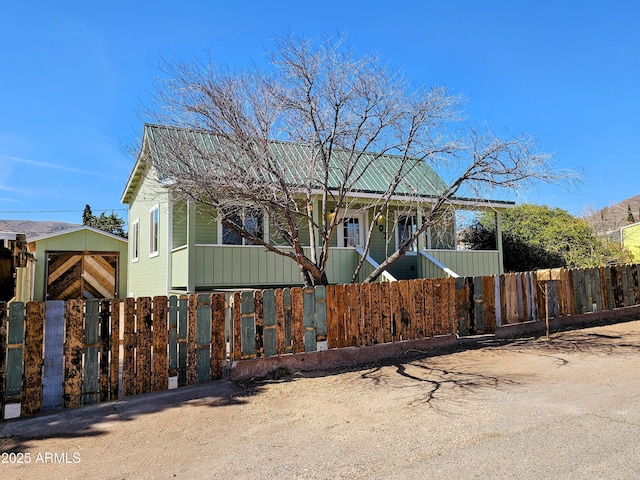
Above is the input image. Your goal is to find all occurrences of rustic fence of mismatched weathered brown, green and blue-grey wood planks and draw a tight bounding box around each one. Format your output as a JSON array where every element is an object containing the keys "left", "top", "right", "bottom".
[{"left": 0, "top": 265, "right": 640, "bottom": 419}]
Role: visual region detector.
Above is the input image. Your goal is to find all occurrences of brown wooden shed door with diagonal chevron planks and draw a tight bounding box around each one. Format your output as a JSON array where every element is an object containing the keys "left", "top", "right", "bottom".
[{"left": 45, "top": 252, "right": 119, "bottom": 300}]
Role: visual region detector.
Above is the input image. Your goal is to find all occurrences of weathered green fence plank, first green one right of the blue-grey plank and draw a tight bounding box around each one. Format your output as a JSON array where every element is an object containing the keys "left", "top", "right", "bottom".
[{"left": 82, "top": 299, "right": 100, "bottom": 405}]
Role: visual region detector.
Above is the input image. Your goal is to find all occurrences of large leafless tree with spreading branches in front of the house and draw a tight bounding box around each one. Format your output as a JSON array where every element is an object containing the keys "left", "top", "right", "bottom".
[{"left": 141, "top": 36, "right": 567, "bottom": 285}]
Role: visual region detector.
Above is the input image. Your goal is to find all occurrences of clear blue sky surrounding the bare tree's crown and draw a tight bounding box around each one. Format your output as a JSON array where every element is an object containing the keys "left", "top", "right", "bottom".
[{"left": 0, "top": 0, "right": 640, "bottom": 223}]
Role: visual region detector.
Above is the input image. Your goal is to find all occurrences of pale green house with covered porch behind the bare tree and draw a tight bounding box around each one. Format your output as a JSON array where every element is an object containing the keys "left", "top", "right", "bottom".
[{"left": 121, "top": 124, "right": 514, "bottom": 296}]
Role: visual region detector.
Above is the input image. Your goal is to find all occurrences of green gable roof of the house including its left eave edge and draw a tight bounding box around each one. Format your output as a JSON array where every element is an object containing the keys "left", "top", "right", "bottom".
[{"left": 121, "top": 124, "right": 513, "bottom": 206}]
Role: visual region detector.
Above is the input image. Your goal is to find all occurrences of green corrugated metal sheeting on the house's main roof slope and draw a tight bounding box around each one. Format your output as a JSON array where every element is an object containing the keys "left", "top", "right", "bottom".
[{"left": 145, "top": 124, "right": 446, "bottom": 197}]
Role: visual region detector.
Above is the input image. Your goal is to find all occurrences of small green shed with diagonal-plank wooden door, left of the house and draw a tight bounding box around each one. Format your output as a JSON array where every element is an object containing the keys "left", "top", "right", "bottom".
[{"left": 29, "top": 226, "right": 128, "bottom": 300}]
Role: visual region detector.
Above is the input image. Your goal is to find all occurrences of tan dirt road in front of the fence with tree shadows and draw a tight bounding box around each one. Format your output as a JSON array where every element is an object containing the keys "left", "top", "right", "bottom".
[{"left": 0, "top": 321, "right": 640, "bottom": 479}]
